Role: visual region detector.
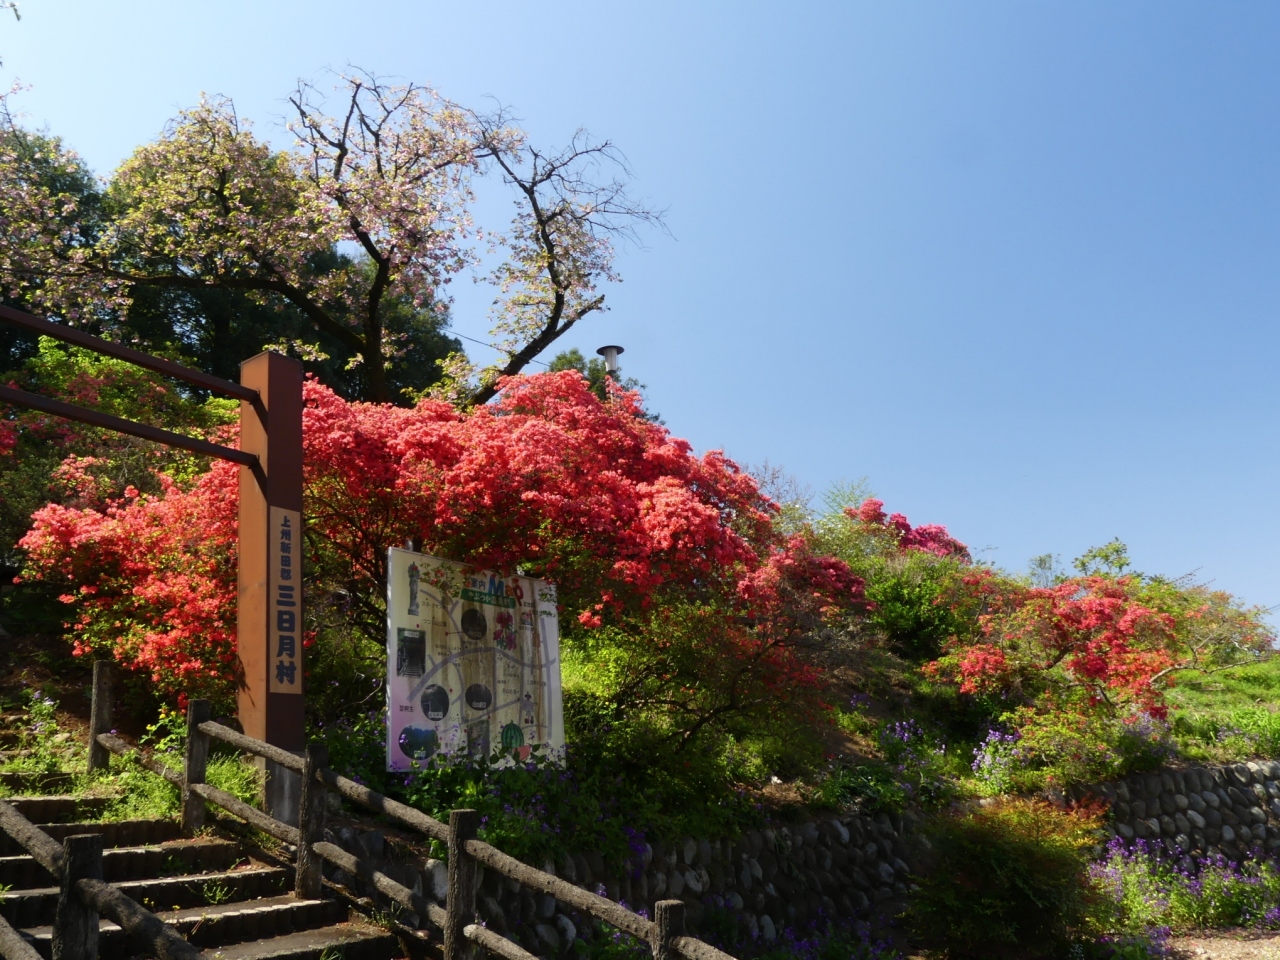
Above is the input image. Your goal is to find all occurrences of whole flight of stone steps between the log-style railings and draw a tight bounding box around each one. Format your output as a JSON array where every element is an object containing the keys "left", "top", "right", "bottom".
[{"left": 0, "top": 796, "right": 404, "bottom": 960}]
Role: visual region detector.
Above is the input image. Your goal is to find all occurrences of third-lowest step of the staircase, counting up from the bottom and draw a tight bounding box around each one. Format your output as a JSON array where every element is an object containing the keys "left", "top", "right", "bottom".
[{"left": 0, "top": 867, "right": 293, "bottom": 927}]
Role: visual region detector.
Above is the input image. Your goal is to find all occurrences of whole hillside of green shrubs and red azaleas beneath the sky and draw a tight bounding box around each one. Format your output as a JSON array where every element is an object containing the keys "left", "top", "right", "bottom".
[{"left": 0, "top": 343, "right": 1280, "bottom": 957}]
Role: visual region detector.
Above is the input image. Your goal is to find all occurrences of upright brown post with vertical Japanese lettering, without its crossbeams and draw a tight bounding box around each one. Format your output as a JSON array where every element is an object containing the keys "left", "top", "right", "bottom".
[{"left": 236, "top": 353, "right": 306, "bottom": 824}]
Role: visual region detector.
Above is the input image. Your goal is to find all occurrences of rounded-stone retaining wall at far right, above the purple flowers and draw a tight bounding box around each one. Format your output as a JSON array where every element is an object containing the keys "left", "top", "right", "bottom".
[{"left": 1089, "top": 760, "right": 1280, "bottom": 868}]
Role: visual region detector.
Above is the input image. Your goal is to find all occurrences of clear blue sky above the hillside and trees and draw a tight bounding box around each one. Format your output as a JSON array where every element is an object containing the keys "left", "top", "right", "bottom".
[{"left": 0, "top": 0, "right": 1280, "bottom": 605}]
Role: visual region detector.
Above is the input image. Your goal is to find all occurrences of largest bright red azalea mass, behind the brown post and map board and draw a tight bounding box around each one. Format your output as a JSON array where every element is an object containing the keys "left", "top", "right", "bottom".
[{"left": 22, "top": 371, "right": 861, "bottom": 716}]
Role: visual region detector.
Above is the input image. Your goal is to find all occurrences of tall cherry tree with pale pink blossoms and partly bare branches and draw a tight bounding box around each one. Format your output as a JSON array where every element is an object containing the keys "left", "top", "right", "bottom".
[{"left": 0, "top": 73, "right": 659, "bottom": 403}]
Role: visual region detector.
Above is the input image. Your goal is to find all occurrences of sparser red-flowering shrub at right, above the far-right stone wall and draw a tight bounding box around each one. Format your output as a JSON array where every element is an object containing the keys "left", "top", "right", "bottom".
[{"left": 911, "top": 543, "right": 1274, "bottom": 788}]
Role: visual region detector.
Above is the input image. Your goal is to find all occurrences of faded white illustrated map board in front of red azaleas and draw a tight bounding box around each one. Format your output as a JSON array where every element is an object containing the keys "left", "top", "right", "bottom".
[{"left": 387, "top": 548, "right": 564, "bottom": 771}]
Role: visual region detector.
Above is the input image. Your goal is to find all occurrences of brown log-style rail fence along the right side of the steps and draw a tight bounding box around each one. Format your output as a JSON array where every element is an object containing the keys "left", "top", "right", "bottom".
[{"left": 72, "top": 660, "right": 735, "bottom": 960}]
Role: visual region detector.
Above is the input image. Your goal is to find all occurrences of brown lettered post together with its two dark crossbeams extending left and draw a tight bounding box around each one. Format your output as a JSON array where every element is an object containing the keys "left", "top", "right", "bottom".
[{"left": 0, "top": 305, "right": 306, "bottom": 824}]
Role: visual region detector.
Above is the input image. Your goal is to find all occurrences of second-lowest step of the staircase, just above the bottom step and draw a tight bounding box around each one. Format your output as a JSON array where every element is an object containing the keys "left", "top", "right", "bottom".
[{"left": 23, "top": 895, "right": 347, "bottom": 960}]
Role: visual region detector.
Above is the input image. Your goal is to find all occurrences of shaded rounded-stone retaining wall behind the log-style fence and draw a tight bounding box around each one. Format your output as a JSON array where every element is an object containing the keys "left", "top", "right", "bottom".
[{"left": 330, "top": 814, "right": 914, "bottom": 956}]
